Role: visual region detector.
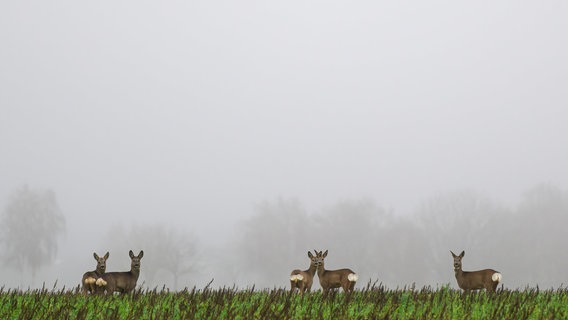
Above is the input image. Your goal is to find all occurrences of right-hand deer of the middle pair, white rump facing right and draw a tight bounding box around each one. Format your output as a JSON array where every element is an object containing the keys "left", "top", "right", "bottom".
[{"left": 316, "top": 250, "right": 359, "bottom": 295}]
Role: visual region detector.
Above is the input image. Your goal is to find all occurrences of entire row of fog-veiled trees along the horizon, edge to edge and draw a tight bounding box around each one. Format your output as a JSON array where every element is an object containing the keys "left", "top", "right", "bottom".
[{"left": 0, "top": 184, "right": 568, "bottom": 290}]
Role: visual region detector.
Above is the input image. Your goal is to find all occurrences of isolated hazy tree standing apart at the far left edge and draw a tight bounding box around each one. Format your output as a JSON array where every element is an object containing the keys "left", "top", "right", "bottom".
[{"left": 0, "top": 186, "right": 65, "bottom": 285}]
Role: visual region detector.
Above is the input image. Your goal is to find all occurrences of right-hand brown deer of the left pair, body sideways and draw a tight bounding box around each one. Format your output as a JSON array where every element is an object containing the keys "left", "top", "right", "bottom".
[{"left": 96, "top": 250, "right": 144, "bottom": 295}]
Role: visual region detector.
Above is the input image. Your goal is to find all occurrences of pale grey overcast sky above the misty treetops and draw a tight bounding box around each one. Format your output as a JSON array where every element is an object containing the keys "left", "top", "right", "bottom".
[{"left": 0, "top": 1, "right": 568, "bottom": 252}]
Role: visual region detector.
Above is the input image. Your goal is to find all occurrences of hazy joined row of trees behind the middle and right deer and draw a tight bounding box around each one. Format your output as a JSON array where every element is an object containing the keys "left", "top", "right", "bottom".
[{"left": 230, "top": 184, "right": 568, "bottom": 288}]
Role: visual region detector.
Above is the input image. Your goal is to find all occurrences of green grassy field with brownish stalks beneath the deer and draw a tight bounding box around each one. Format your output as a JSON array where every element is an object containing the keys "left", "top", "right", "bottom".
[{"left": 0, "top": 285, "right": 568, "bottom": 319}]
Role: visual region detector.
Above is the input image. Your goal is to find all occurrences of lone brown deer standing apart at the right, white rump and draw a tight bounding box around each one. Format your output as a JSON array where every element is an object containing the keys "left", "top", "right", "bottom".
[{"left": 450, "top": 250, "right": 502, "bottom": 292}]
